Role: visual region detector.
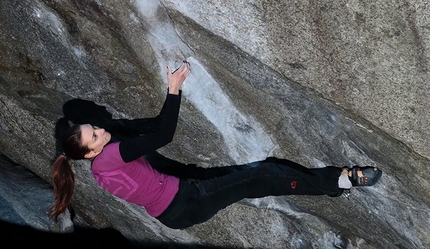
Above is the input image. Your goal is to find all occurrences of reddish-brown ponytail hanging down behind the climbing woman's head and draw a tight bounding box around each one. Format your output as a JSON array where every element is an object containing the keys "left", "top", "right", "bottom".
[{"left": 51, "top": 155, "right": 75, "bottom": 220}]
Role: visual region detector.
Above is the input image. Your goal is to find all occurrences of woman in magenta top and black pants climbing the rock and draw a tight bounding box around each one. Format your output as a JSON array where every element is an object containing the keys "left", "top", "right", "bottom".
[{"left": 51, "top": 62, "right": 382, "bottom": 229}]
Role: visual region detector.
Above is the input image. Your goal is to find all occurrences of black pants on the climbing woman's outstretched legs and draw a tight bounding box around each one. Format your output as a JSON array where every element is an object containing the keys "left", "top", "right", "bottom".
[{"left": 157, "top": 158, "right": 342, "bottom": 229}]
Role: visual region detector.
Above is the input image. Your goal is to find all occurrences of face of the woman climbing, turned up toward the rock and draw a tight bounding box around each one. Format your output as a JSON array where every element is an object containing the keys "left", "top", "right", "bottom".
[{"left": 81, "top": 124, "right": 111, "bottom": 158}]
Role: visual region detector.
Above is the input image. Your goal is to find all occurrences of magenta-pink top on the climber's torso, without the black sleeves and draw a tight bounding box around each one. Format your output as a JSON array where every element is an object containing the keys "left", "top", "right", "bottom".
[{"left": 91, "top": 142, "right": 179, "bottom": 217}]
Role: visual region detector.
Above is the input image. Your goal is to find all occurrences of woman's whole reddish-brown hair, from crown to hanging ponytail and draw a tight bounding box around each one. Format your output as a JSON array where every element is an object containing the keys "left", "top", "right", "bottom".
[{"left": 50, "top": 125, "right": 90, "bottom": 220}]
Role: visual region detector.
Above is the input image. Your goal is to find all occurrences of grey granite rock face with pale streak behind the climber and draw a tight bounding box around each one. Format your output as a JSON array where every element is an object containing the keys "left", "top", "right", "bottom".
[{"left": 0, "top": 0, "right": 430, "bottom": 248}]
